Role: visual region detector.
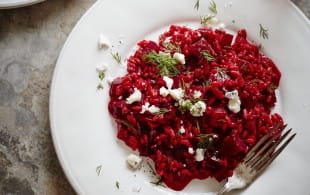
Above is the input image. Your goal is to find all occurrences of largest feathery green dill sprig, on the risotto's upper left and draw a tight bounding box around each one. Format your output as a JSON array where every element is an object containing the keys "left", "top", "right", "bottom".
[{"left": 143, "top": 51, "right": 179, "bottom": 76}]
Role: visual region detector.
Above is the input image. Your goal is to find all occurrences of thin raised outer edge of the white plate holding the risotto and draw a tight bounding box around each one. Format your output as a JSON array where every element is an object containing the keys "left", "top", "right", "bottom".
[{"left": 49, "top": 0, "right": 310, "bottom": 194}]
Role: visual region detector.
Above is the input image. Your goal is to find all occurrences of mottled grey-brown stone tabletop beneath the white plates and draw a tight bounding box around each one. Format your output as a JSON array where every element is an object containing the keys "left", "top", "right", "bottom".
[{"left": 0, "top": 0, "right": 310, "bottom": 195}]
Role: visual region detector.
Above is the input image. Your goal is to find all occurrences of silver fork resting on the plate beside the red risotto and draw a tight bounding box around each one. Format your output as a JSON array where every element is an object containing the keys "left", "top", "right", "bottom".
[{"left": 216, "top": 123, "right": 296, "bottom": 195}]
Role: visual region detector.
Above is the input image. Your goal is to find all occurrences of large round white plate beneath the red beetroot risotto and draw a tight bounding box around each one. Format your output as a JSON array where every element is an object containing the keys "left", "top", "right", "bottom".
[{"left": 50, "top": 0, "right": 310, "bottom": 195}]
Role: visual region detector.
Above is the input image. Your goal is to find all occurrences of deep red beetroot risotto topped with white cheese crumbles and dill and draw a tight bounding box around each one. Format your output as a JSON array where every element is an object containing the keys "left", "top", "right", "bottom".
[{"left": 109, "top": 26, "right": 282, "bottom": 190}]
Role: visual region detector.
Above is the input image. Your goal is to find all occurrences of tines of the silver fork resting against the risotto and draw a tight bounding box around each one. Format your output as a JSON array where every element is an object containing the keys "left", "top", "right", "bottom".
[{"left": 243, "top": 123, "right": 296, "bottom": 173}]
